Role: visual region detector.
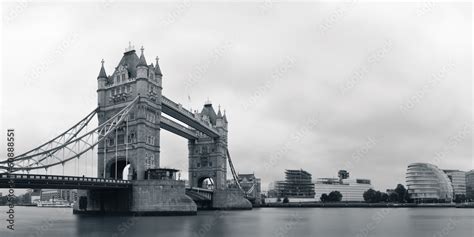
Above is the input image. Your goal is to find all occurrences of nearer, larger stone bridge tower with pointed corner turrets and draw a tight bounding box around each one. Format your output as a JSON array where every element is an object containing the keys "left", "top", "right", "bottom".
[{"left": 97, "top": 45, "right": 163, "bottom": 180}]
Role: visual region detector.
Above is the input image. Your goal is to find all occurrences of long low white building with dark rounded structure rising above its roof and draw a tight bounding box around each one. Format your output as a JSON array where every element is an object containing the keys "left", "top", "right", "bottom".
[{"left": 314, "top": 170, "right": 373, "bottom": 202}]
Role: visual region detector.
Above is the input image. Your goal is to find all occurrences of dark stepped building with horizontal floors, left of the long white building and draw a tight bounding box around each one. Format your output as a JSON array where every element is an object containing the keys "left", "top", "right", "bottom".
[{"left": 275, "top": 169, "right": 314, "bottom": 198}]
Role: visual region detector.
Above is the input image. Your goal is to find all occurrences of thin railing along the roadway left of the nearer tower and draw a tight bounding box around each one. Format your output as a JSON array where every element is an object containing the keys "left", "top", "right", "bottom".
[{"left": 0, "top": 174, "right": 131, "bottom": 184}]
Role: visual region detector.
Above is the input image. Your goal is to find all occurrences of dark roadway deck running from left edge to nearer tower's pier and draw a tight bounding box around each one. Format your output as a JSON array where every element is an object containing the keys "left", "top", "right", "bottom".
[{"left": 0, "top": 174, "right": 132, "bottom": 190}]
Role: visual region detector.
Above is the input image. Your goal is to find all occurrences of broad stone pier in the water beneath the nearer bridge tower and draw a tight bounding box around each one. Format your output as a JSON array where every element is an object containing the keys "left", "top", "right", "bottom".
[{"left": 73, "top": 179, "right": 197, "bottom": 216}]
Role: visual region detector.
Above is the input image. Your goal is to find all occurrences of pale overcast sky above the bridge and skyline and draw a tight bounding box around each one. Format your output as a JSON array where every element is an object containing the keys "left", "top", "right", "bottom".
[{"left": 1, "top": 1, "right": 473, "bottom": 190}]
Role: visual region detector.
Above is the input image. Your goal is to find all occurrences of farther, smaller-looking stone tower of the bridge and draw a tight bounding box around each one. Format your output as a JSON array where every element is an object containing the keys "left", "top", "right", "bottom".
[{"left": 188, "top": 101, "right": 228, "bottom": 190}]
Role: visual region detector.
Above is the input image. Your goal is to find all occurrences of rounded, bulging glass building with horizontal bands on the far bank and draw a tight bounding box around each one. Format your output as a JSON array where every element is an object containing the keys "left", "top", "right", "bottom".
[{"left": 406, "top": 163, "right": 453, "bottom": 202}]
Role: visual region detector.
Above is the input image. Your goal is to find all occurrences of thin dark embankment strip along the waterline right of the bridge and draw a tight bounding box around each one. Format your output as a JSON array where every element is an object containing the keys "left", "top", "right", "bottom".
[{"left": 260, "top": 202, "right": 474, "bottom": 208}]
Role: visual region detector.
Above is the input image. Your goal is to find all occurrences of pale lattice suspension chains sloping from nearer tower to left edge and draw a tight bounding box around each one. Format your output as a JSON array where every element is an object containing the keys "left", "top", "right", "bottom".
[{"left": 0, "top": 97, "right": 139, "bottom": 173}]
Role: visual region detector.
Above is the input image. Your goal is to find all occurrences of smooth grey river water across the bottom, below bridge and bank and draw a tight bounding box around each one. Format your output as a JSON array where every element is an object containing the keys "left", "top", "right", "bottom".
[{"left": 0, "top": 207, "right": 474, "bottom": 237}]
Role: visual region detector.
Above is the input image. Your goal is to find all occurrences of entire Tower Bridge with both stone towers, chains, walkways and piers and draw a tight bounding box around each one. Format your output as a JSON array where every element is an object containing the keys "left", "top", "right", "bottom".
[{"left": 0, "top": 44, "right": 259, "bottom": 215}]
